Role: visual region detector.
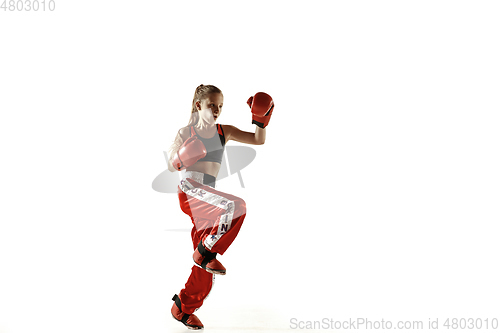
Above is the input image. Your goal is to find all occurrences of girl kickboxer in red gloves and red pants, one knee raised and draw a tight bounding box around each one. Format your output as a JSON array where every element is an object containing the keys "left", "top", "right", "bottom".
[{"left": 168, "top": 85, "right": 274, "bottom": 329}]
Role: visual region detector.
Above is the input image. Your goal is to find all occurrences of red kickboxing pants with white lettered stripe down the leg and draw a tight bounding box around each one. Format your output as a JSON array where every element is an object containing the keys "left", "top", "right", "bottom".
[{"left": 178, "top": 178, "right": 246, "bottom": 314}]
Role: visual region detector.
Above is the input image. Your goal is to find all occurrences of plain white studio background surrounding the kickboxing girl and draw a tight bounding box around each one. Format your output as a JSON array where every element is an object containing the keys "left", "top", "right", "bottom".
[{"left": 0, "top": 0, "right": 500, "bottom": 333}]
